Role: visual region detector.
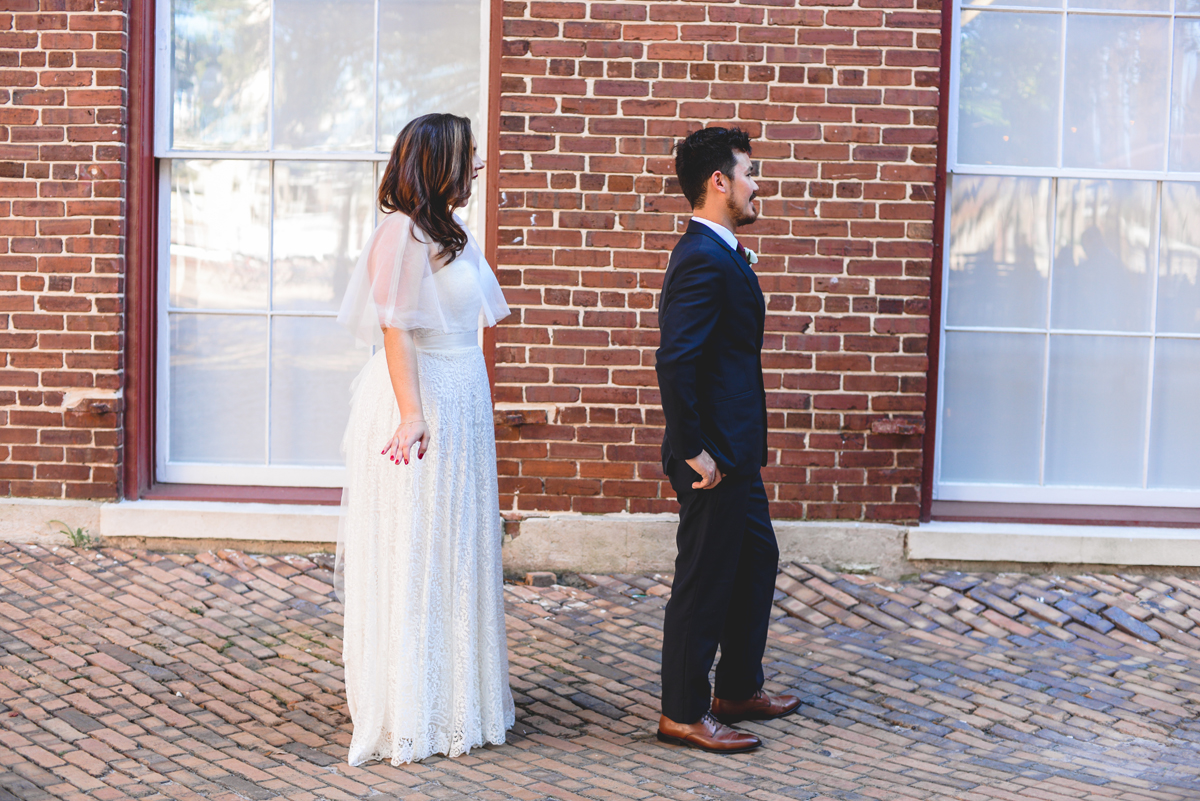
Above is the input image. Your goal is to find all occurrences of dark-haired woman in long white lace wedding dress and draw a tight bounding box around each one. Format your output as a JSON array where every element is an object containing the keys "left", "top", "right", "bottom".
[{"left": 336, "top": 114, "right": 514, "bottom": 765}]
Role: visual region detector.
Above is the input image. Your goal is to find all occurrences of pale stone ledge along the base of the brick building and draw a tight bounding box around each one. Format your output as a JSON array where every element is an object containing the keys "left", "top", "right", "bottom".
[{"left": 9, "top": 499, "right": 1200, "bottom": 578}]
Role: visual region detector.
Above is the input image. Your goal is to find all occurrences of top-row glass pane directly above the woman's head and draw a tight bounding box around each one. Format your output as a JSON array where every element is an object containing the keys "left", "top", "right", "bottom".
[{"left": 378, "top": 0, "right": 482, "bottom": 152}]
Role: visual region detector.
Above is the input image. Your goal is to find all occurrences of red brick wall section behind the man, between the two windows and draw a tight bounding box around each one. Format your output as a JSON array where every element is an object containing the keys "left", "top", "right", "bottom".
[{"left": 496, "top": 0, "right": 941, "bottom": 520}]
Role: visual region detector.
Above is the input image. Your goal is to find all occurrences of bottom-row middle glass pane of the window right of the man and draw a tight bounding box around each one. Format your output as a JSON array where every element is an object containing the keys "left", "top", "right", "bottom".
[{"left": 1045, "top": 336, "right": 1150, "bottom": 487}]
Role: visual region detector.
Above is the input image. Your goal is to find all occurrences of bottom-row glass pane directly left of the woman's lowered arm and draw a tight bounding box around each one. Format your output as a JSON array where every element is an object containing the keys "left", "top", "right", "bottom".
[{"left": 271, "top": 317, "right": 369, "bottom": 466}]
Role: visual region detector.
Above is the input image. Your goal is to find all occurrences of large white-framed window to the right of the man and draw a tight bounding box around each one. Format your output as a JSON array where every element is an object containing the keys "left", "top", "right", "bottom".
[{"left": 934, "top": 0, "right": 1200, "bottom": 506}]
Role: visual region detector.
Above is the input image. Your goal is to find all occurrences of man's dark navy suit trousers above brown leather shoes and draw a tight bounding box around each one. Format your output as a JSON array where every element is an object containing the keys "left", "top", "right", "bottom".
[{"left": 662, "top": 459, "right": 779, "bottom": 723}]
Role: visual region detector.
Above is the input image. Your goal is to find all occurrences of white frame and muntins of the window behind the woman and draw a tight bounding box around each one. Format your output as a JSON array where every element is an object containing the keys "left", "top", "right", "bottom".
[{"left": 154, "top": 0, "right": 492, "bottom": 488}]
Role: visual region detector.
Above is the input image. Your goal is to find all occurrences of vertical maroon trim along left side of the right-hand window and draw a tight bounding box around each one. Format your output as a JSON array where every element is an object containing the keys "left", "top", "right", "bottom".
[{"left": 919, "top": 2, "right": 954, "bottom": 523}]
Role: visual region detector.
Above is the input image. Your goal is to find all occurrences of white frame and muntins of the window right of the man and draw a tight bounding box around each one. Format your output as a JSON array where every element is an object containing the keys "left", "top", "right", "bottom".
[{"left": 932, "top": 0, "right": 1200, "bottom": 507}]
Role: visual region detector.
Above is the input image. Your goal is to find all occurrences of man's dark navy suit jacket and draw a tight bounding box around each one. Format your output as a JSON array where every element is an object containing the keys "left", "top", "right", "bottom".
[{"left": 655, "top": 221, "right": 767, "bottom": 475}]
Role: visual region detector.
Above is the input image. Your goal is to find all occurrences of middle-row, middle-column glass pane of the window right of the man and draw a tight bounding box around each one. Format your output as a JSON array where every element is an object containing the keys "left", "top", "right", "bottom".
[{"left": 1050, "top": 179, "right": 1154, "bottom": 331}]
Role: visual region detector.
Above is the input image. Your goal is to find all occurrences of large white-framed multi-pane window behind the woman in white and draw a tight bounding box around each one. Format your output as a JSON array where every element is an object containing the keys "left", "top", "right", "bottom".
[{"left": 155, "top": 0, "right": 487, "bottom": 487}]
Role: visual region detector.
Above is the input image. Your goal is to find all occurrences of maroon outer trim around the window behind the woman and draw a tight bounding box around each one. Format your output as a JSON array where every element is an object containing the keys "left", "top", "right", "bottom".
[{"left": 121, "top": 0, "right": 504, "bottom": 505}]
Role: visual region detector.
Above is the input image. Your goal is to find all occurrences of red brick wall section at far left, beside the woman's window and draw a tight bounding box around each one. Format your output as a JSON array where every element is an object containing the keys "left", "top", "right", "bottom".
[{"left": 0, "top": 0, "right": 127, "bottom": 498}]
